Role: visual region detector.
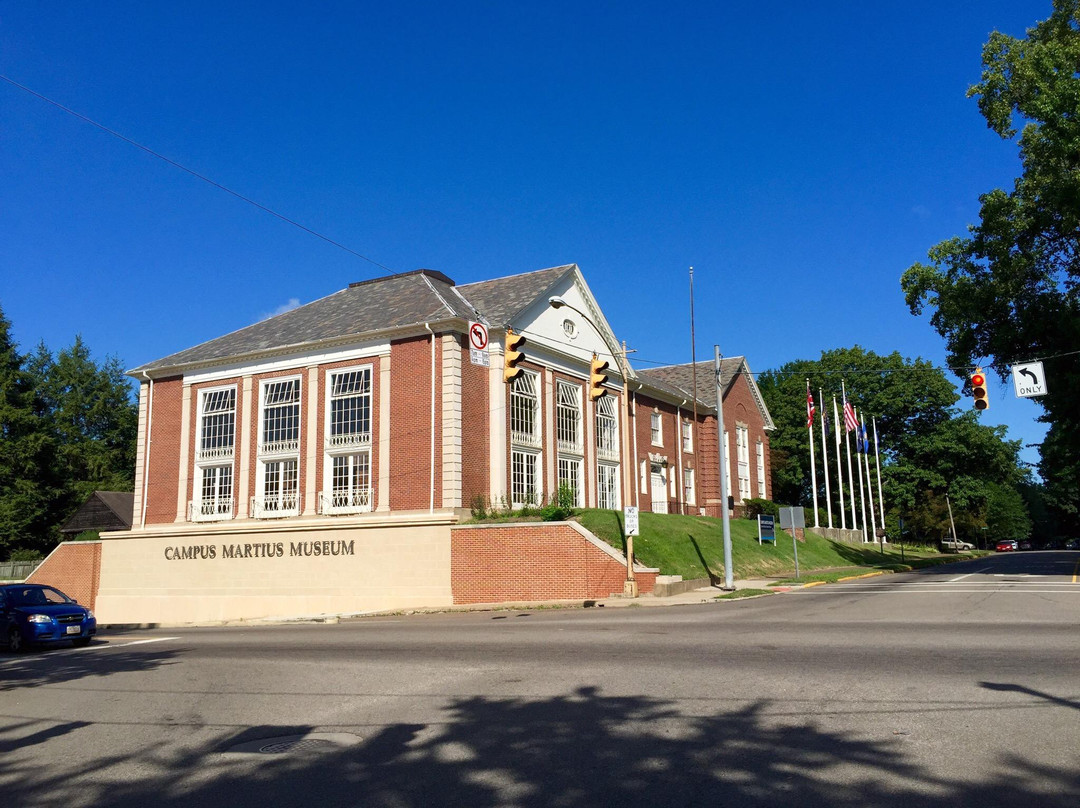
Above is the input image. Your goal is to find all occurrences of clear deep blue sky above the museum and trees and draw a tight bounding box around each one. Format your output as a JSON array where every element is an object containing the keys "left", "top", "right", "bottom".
[{"left": 0, "top": 0, "right": 1053, "bottom": 460}]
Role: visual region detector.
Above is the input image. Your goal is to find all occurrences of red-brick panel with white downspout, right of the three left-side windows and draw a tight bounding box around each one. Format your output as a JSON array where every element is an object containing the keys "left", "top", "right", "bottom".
[{"left": 390, "top": 336, "right": 443, "bottom": 511}]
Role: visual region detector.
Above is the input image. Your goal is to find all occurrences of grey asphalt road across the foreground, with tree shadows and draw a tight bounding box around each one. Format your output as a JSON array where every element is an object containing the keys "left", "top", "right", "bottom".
[{"left": 0, "top": 552, "right": 1080, "bottom": 808}]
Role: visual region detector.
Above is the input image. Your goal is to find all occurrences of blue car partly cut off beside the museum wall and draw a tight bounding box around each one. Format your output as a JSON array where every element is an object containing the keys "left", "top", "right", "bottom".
[{"left": 0, "top": 583, "right": 97, "bottom": 654}]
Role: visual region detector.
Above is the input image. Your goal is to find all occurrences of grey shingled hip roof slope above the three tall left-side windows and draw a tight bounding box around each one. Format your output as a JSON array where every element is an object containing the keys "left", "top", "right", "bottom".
[{"left": 129, "top": 270, "right": 475, "bottom": 374}]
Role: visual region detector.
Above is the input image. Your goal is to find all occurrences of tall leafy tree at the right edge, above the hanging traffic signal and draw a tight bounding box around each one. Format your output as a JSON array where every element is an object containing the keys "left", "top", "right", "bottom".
[{"left": 901, "top": 0, "right": 1080, "bottom": 525}]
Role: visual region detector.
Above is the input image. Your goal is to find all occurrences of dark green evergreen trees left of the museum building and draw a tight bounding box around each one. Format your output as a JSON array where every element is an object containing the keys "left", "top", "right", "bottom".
[{"left": 0, "top": 302, "right": 138, "bottom": 557}]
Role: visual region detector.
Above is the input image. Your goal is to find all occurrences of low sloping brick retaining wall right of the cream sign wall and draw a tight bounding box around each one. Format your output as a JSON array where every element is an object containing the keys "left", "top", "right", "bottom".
[{"left": 450, "top": 522, "right": 657, "bottom": 604}]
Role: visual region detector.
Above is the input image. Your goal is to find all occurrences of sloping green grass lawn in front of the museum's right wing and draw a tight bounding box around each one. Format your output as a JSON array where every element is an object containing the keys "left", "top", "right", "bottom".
[{"left": 578, "top": 509, "right": 956, "bottom": 582}]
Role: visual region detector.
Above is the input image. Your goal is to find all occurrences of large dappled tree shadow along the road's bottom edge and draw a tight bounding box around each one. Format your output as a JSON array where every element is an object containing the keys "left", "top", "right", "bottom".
[{"left": 0, "top": 688, "right": 1080, "bottom": 808}]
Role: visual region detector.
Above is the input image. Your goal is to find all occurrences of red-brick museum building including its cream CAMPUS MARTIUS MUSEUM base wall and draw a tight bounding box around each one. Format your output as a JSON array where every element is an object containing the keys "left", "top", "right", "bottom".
[{"left": 31, "top": 265, "right": 772, "bottom": 623}]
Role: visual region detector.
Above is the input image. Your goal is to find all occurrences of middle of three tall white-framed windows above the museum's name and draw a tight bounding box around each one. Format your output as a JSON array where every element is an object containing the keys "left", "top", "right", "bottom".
[{"left": 252, "top": 377, "right": 300, "bottom": 519}]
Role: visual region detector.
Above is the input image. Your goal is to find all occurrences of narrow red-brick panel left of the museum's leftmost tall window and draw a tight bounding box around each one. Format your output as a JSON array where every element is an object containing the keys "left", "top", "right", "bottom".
[{"left": 145, "top": 376, "right": 184, "bottom": 525}]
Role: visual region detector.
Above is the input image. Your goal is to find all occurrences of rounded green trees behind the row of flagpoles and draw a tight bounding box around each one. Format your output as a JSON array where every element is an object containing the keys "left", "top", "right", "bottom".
[{"left": 758, "top": 346, "right": 1031, "bottom": 540}]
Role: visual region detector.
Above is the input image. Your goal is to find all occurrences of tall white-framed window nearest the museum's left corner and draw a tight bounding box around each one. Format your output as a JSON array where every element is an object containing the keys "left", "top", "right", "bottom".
[{"left": 188, "top": 386, "right": 237, "bottom": 522}]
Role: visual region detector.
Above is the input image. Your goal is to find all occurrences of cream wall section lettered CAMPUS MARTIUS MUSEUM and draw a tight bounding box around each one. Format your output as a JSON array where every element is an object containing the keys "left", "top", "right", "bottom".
[{"left": 94, "top": 517, "right": 453, "bottom": 625}]
